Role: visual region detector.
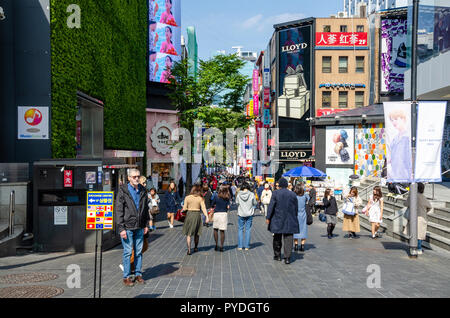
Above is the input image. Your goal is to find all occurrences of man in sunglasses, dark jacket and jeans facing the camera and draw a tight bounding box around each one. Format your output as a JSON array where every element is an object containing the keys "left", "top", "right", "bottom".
[{"left": 115, "top": 169, "right": 150, "bottom": 286}]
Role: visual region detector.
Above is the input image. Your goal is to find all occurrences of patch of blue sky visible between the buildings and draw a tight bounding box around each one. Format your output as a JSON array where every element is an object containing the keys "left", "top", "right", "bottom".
[{"left": 180, "top": 0, "right": 343, "bottom": 59}]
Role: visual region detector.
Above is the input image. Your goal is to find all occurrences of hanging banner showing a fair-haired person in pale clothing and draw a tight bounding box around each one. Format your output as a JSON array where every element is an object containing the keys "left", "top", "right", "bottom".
[{"left": 383, "top": 102, "right": 412, "bottom": 182}]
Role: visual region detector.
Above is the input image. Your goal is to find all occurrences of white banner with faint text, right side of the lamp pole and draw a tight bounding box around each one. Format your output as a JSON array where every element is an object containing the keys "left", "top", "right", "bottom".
[{"left": 414, "top": 102, "right": 447, "bottom": 182}]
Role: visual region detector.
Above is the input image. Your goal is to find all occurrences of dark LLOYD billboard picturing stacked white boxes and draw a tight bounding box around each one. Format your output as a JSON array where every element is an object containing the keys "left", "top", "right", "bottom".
[{"left": 278, "top": 25, "right": 312, "bottom": 119}]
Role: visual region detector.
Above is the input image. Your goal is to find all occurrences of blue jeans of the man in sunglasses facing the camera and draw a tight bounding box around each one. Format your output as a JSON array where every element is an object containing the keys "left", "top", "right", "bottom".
[{"left": 121, "top": 229, "right": 144, "bottom": 278}]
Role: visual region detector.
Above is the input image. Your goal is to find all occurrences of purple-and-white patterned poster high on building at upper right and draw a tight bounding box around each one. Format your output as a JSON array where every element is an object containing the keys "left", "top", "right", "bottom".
[{"left": 380, "top": 17, "right": 407, "bottom": 93}]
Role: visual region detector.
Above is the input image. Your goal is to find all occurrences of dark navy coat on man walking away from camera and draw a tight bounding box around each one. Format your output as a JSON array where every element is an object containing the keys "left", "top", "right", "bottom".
[{"left": 266, "top": 188, "right": 299, "bottom": 234}]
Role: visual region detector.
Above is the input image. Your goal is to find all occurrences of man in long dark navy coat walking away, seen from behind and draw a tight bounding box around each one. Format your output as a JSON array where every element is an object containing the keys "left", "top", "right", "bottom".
[{"left": 266, "top": 179, "right": 300, "bottom": 264}]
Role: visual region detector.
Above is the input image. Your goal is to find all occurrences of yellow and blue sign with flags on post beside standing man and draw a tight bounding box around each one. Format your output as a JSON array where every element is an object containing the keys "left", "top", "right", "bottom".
[{"left": 86, "top": 191, "right": 114, "bottom": 230}]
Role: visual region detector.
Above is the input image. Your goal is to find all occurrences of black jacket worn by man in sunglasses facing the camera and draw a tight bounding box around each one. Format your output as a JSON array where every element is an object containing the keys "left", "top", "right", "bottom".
[{"left": 115, "top": 184, "right": 150, "bottom": 233}]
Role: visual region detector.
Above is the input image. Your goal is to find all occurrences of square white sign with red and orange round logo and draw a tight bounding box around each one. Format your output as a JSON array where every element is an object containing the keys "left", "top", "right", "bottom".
[{"left": 17, "top": 106, "right": 49, "bottom": 139}]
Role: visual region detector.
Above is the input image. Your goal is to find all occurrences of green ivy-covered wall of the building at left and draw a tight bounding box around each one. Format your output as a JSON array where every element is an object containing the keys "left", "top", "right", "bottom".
[{"left": 50, "top": 0, "right": 148, "bottom": 158}]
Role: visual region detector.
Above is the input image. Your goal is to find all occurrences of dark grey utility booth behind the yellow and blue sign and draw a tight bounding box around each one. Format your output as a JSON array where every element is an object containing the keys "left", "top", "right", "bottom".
[{"left": 33, "top": 159, "right": 124, "bottom": 253}]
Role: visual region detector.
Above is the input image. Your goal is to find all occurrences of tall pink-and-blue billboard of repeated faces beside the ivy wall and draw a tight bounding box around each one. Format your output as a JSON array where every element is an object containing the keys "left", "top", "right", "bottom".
[{"left": 148, "top": 0, "right": 181, "bottom": 83}]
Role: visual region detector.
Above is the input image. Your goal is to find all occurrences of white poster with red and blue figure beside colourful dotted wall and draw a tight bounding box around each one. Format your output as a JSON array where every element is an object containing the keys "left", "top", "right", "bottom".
[{"left": 326, "top": 126, "right": 355, "bottom": 165}]
